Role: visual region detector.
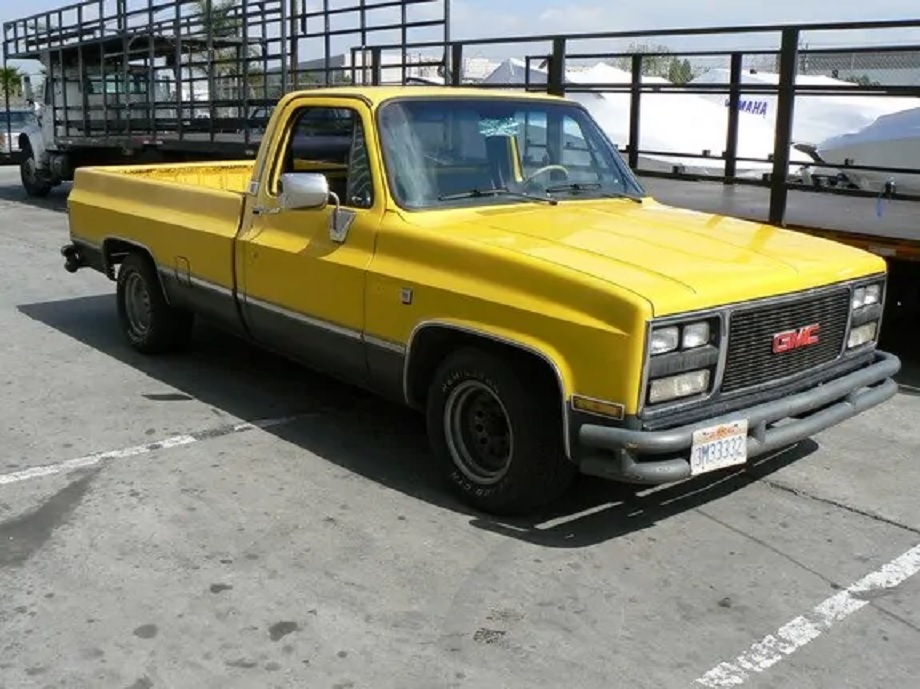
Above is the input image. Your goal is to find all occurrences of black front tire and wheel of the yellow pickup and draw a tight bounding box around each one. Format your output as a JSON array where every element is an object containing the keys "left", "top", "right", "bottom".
[{"left": 427, "top": 349, "right": 575, "bottom": 515}]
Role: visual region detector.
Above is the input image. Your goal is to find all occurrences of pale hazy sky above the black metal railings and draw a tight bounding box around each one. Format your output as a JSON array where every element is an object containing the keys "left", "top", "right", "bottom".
[{"left": 0, "top": 0, "right": 920, "bottom": 74}]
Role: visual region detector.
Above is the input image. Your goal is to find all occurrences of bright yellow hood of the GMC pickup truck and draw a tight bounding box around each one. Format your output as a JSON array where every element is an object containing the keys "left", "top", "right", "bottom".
[{"left": 446, "top": 199, "right": 885, "bottom": 315}]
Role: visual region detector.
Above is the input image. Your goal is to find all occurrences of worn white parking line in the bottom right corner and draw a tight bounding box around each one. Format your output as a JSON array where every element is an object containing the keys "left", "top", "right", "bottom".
[{"left": 696, "top": 545, "right": 920, "bottom": 687}]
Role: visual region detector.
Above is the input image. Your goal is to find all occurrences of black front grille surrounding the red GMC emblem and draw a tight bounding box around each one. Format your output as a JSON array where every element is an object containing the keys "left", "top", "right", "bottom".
[{"left": 721, "top": 287, "right": 850, "bottom": 393}]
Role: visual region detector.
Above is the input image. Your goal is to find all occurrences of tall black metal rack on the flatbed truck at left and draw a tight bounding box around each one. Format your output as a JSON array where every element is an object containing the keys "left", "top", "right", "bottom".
[{"left": 3, "top": 0, "right": 450, "bottom": 155}]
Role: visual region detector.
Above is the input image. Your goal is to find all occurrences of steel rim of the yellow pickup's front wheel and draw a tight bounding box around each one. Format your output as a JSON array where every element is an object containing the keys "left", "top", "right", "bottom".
[{"left": 444, "top": 380, "right": 514, "bottom": 485}]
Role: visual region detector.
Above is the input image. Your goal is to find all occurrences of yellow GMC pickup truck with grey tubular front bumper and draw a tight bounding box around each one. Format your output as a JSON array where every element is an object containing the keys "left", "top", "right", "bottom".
[{"left": 62, "top": 86, "right": 900, "bottom": 513}]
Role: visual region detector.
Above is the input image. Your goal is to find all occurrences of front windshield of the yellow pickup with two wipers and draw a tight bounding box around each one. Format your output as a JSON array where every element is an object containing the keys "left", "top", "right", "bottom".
[{"left": 379, "top": 96, "right": 644, "bottom": 209}]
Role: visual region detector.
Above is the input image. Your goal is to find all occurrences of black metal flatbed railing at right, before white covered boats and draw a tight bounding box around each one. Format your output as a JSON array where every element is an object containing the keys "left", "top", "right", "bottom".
[{"left": 363, "top": 19, "right": 920, "bottom": 224}]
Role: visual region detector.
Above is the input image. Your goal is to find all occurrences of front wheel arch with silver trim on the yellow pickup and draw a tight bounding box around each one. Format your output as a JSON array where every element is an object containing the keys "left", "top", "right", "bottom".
[{"left": 403, "top": 321, "right": 572, "bottom": 458}]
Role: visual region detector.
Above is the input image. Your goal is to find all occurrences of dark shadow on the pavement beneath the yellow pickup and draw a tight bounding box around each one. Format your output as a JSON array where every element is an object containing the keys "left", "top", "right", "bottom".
[{"left": 19, "top": 295, "right": 912, "bottom": 548}]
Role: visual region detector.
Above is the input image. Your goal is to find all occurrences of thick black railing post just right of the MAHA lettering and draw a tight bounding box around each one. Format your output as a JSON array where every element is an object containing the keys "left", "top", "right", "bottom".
[{"left": 769, "top": 28, "right": 799, "bottom": 225}]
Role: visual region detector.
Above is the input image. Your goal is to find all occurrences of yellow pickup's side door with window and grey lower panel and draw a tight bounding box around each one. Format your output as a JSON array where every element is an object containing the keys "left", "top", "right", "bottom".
[{"left": 237, "top": 96, "right": 384, "bottom": 384}]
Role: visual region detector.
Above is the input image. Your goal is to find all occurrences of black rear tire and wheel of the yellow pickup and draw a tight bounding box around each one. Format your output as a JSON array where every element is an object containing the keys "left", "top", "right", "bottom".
[{"left": 116, "top": 253, "right": 195, "bottom": 354}]
